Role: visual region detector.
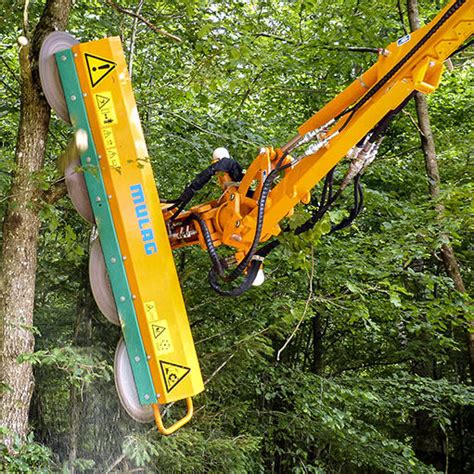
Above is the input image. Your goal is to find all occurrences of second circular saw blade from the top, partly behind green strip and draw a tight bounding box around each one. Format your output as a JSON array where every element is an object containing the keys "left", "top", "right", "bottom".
[{"left": 64, "top": 147, "right": 95, "bottom": 224}]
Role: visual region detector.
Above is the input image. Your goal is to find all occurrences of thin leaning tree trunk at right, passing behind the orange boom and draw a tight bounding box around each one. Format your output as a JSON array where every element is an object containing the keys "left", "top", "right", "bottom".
[{"left": 407, "top": 0, "right": 474, "bottom": 380}]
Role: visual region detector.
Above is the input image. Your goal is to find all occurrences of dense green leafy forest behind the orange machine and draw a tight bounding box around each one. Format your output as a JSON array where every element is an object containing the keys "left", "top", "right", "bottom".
[{"left": 0, "top": 0, "right": 474, "bottom": 473}]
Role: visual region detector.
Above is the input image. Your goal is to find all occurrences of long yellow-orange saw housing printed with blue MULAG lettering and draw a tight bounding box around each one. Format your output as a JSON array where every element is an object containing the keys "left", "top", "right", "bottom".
[{"left": 72, "top": 38, "right": 204, "bottom": 432}]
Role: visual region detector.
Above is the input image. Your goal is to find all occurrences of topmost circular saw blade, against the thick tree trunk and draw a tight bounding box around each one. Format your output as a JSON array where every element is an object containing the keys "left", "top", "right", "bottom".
[{"left": 38, "top": 31, "right": 79, "bottom": 123}]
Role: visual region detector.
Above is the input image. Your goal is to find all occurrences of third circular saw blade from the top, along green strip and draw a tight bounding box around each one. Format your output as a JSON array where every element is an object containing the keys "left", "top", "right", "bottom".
[{"left": 89, "top": 239, "right": 120, "bottom": 326}]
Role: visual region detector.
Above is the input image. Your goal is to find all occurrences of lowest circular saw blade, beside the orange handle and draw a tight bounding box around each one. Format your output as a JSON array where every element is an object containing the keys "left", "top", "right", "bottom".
[{"left": 114, "top": 339, "right": 154, "bottom": 423}]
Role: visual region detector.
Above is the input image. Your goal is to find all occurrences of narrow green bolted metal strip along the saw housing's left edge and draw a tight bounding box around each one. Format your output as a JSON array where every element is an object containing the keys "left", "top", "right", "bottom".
[{"left": 56, "top": 50, "right": 157, "bottom": 405}]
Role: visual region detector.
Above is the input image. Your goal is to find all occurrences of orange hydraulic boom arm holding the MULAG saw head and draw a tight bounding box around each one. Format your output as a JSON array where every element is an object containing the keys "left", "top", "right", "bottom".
[{"left": 165, "top": 0, "right": 474, "bottom": 261}]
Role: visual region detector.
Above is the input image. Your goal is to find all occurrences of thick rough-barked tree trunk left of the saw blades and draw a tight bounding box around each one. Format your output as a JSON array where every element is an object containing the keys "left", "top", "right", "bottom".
[{"left": 0, "top": 0, "right": 72, "bottom": 446}]
